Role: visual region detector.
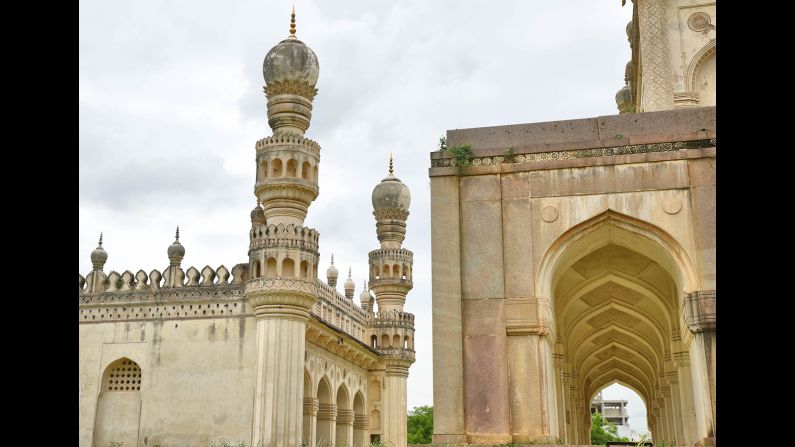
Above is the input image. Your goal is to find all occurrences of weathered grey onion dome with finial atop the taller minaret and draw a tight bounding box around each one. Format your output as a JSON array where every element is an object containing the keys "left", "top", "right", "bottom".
[{"left": 262, "top": 8, "right": 320, "bottom": 87}]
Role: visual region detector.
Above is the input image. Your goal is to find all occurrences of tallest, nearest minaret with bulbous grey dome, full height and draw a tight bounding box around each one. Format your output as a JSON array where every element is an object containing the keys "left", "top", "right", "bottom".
[{"left": 244, "top": 10, "right": 320, "bottom": 447}]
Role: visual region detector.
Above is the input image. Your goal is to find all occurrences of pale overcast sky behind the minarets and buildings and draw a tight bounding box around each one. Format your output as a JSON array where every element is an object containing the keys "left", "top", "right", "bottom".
[{"left": 78, "top": 0, "right": 645, "bottom": 426}]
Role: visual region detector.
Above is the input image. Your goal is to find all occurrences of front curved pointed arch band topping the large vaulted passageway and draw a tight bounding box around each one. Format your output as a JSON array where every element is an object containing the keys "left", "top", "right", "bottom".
[{"left": 535, "top": 208, "right": 699, "bottom": 298}]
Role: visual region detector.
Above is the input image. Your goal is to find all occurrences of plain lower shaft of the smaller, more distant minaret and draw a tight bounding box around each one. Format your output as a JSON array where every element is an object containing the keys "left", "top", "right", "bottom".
[{"left": 381, "top": 364, "right": 409, "bottom": 447}]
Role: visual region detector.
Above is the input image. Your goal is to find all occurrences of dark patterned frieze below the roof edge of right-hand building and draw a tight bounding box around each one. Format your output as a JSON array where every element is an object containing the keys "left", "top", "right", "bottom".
[{"left": 431, "top": 138, "right": 717, "bottom": 168}]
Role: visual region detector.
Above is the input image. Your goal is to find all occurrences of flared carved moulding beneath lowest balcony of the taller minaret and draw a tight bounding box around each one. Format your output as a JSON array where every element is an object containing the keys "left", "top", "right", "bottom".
[{"left": 243, "top": 277, "right": 317, "bottom": 319}]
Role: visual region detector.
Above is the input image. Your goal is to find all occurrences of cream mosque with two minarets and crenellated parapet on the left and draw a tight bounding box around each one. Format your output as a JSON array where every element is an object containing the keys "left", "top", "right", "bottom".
[{"left": 79, "top": 13, "right": 414, "bottom": 447}]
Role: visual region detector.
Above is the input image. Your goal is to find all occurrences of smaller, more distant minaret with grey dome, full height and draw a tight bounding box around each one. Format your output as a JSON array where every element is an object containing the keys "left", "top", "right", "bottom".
[{"left": 369, "top": 156, "right": 414, "bottom": 447}]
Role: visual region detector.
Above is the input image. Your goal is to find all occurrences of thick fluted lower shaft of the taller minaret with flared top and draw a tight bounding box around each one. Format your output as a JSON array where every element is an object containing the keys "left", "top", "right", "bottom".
[{"left": 244, "top": 278, "right": 317, "bottom": 447}]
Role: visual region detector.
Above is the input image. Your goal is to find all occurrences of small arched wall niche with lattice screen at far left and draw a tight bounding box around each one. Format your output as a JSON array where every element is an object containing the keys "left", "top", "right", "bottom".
[{"left": 94, "top": 357, "right": 142, "bottom": 447}]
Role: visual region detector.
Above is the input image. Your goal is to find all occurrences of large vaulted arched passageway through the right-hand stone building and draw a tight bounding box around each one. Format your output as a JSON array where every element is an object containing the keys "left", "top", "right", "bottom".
[{"left": 537, "top": 210, "right": 705, "bottom": 445}]
